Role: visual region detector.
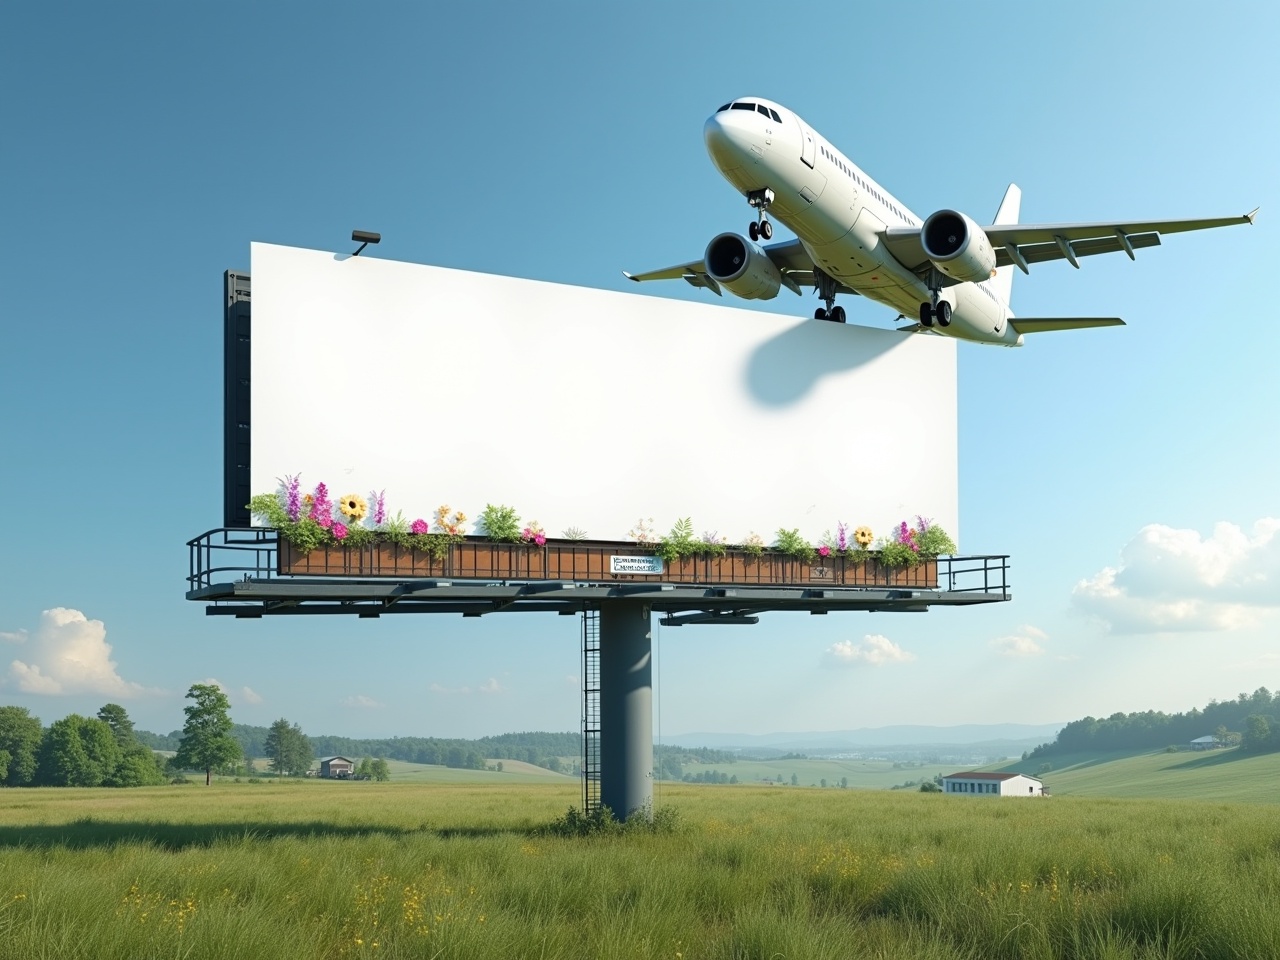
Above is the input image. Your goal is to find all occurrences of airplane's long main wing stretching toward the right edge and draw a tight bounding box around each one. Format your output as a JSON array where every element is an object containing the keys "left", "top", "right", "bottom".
[{"left": 881, "top": 209, "right": 1258, "bottom": 273}]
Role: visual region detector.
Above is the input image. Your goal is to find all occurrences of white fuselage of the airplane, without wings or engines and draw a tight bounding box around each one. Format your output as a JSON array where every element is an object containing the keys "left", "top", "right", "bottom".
[{"left": 703, "top": 97, "right": 1021, "bottom": 347}]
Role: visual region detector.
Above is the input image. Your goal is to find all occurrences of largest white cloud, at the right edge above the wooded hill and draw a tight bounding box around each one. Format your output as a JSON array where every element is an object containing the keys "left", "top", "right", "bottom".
[{"left": 1071, "top": 517, "right": 1280, "bottom": 634}]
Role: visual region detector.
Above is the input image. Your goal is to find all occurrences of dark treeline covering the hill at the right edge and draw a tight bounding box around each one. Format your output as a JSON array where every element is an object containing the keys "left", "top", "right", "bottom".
[{"left": 1023, "top": 686, "right": 1280, "bottom": 759}]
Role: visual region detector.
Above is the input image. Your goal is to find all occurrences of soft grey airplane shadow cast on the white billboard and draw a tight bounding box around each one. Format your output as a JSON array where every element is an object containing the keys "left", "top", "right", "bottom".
[{"left": 746, "top": 320, "right": 909, "bottom": 407}]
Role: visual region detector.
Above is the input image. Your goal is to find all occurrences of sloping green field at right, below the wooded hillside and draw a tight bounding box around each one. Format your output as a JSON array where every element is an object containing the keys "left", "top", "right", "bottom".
[{"left": 989, "top": 749, "right": 1280, "bottom": 803}]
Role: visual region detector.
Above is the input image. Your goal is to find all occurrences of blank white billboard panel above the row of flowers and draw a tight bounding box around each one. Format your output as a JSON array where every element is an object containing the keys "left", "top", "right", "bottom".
[{"left": 250, "top": 243, "right": 959, "bottom": 543}]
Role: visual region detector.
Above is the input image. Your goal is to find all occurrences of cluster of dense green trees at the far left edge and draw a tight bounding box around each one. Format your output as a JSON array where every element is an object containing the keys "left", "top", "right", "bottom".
[{"left": 0, "top": 703, "right": 168, "bottom": 787}]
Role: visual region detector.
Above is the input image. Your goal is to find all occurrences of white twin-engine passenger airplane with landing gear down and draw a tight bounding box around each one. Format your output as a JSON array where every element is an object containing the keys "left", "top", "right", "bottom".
[{"left": 623, "top": 97, "right": 1258, "bottom": 347}]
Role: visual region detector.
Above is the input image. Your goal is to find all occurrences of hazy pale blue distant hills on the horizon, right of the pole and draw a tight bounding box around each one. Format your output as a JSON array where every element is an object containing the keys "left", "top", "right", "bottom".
[{"left": 662, "top": 723, "right": 1064, "bottom": 753}]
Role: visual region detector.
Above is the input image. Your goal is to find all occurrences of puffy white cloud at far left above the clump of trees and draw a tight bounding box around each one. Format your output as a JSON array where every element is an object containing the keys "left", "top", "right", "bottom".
[{"left": 6, "top": 607, "right": 157, "bottom": 699}]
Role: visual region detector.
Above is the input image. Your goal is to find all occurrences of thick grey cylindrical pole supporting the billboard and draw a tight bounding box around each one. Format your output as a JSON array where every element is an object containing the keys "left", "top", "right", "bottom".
[{"left": 600, "top": 599, "right": 653, "bottom": 820}]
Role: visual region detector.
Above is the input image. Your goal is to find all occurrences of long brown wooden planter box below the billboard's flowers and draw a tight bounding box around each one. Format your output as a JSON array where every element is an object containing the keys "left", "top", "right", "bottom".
[{"left": 276, "top": 538, "right": 938, "bottom": 590}]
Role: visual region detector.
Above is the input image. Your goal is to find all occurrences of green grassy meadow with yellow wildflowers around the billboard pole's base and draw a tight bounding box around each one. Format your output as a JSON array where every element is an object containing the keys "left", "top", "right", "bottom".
[{"left": 0, "top": 781, "right": 1280, "bottom": 960}]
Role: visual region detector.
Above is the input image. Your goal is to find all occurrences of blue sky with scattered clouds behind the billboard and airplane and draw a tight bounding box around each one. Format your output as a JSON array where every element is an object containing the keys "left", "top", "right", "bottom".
[{"left": 0, "top": 3, "right": 1280, "bottom": 736}]
